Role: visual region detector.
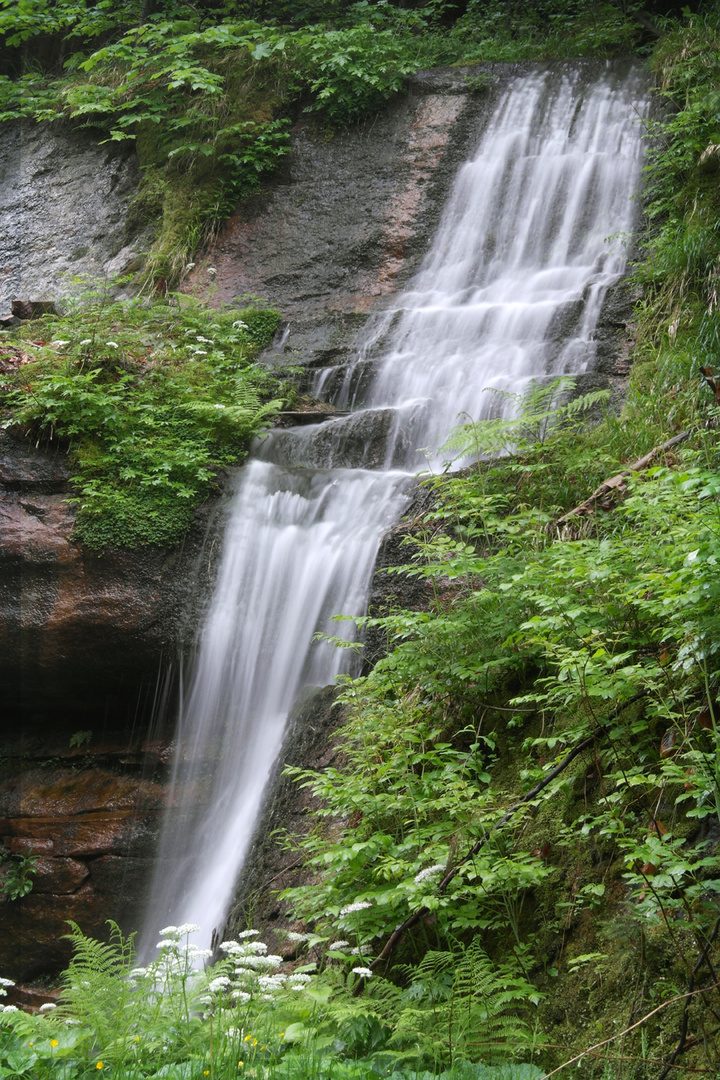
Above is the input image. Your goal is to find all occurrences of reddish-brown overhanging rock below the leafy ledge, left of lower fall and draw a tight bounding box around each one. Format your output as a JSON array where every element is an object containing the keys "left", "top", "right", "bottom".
[{"left": 0, "top": 433, "right": 223, "bottom": 730}]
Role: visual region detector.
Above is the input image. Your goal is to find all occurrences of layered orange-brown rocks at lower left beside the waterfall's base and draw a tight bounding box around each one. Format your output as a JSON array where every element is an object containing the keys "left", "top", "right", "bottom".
[{"left": 0, "top": 747, "right": 163, "bottom": 981}]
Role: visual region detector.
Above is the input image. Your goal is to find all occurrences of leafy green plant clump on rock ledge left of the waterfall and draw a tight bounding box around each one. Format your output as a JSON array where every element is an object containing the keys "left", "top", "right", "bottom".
[{"left": 0, "top": 296, "right": 280, "bottom": 548}]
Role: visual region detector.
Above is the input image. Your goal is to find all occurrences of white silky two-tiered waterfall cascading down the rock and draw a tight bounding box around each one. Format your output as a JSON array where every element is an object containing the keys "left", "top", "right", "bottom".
[{"left": 147, "top": 65, "right": 647, "bottom": 943}]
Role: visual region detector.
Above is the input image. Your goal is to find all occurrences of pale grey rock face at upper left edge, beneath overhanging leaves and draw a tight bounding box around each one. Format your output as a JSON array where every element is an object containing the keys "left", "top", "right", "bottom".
[{"left": 0, "top": 121, "right": 140, "bottom": 315}]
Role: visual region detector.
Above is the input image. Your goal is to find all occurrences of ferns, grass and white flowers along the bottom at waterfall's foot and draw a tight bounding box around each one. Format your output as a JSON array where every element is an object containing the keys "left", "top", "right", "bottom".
[{"left": 0, "top": 923, "right": 541, "bottom": 1080}]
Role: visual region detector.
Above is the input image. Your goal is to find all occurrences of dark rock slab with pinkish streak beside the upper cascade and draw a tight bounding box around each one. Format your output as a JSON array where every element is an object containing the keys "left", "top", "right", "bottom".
[{"left": 186, "top": 65, "right": 535, "bottom": 368}]
